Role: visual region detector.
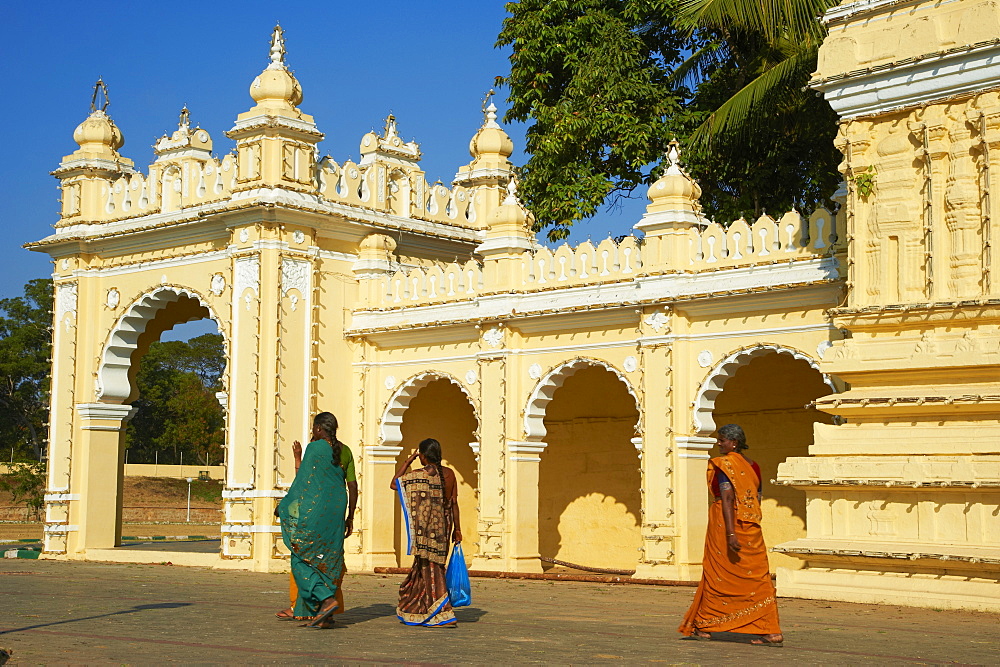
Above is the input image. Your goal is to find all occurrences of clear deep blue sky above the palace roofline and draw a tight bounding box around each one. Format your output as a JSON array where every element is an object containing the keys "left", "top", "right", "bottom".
[{"left": 0, "top": 0, "right": 645, "bottom": 298}]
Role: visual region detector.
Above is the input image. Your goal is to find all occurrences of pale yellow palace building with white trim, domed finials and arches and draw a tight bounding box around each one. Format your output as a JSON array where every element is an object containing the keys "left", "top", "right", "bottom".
[{"left": 28, "top": 0, "right": 1000, "bottom": 609}]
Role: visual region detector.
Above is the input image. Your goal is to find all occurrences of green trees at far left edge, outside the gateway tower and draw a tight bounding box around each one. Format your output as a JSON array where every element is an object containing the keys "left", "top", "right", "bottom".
[{"left": 0, "top": 279, "right": 52, "bottom": 461}]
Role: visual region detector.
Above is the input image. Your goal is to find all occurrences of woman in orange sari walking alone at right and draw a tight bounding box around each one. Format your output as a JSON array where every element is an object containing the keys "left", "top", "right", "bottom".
[{"left": 678, "top": 424, "right": 784, "bottom": 646}]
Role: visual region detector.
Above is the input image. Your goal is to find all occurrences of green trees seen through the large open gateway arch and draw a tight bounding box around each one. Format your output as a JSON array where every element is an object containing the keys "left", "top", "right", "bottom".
[{"left": 125, "top": 334, "right": 226, "bottom": 465}]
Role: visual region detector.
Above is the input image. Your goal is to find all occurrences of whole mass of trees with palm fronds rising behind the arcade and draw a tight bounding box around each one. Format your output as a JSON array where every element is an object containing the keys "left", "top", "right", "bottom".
[{"left": 497, "top": 0, "right": 839, "bottom": 240}]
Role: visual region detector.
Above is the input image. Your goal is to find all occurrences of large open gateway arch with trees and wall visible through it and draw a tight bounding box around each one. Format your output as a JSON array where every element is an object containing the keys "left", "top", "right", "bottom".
[{"left": 98, "top": 287, "right": 228, "bottom": 552}]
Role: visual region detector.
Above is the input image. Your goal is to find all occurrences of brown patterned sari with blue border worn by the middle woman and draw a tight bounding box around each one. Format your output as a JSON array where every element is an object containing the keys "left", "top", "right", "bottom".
[{"left": 396, "top": 466, "right": 455, "bottom": 626}]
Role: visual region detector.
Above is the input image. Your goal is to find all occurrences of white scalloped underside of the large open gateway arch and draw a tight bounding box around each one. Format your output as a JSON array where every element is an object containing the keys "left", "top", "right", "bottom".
[{"left": 97, "top": 285, "right": 229, "bottom": 403}]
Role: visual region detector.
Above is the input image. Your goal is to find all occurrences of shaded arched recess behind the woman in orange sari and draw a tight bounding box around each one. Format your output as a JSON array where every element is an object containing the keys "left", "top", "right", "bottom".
[{"left": 712, "top": 350, "right": 833, "bottom": 570}]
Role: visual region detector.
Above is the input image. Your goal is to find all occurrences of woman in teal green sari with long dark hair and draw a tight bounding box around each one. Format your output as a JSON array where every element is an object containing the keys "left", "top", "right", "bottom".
[{"left": 278, "top": 412, "right": 357, "bottom": 628}]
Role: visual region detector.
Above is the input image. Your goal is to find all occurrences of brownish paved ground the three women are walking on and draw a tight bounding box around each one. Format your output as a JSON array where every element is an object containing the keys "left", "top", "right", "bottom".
[{"left": 0, "top": 559, "right": 1000, "bottom": 665}]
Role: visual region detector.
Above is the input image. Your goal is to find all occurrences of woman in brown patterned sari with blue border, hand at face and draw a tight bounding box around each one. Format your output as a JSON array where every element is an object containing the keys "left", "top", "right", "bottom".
[{"left": 390, "top": 438, "right": 462, "bottom": 627}]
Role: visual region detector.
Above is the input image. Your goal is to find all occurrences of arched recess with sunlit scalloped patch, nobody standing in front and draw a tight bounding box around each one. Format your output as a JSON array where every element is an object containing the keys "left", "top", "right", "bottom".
[{"left": 538, "top": 363, "right": 642, "bottom": 569}]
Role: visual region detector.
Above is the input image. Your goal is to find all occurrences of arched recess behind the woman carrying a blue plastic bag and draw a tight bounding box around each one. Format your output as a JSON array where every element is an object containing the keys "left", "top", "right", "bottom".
[{"left": 394, "top": 376, "right": 479, "bottom": 567}]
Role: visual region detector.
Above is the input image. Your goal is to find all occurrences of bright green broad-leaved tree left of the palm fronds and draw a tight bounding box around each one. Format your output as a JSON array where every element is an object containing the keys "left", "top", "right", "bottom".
[{"left": 497, "top": 0, "right": 685, "bottom": 240}]
